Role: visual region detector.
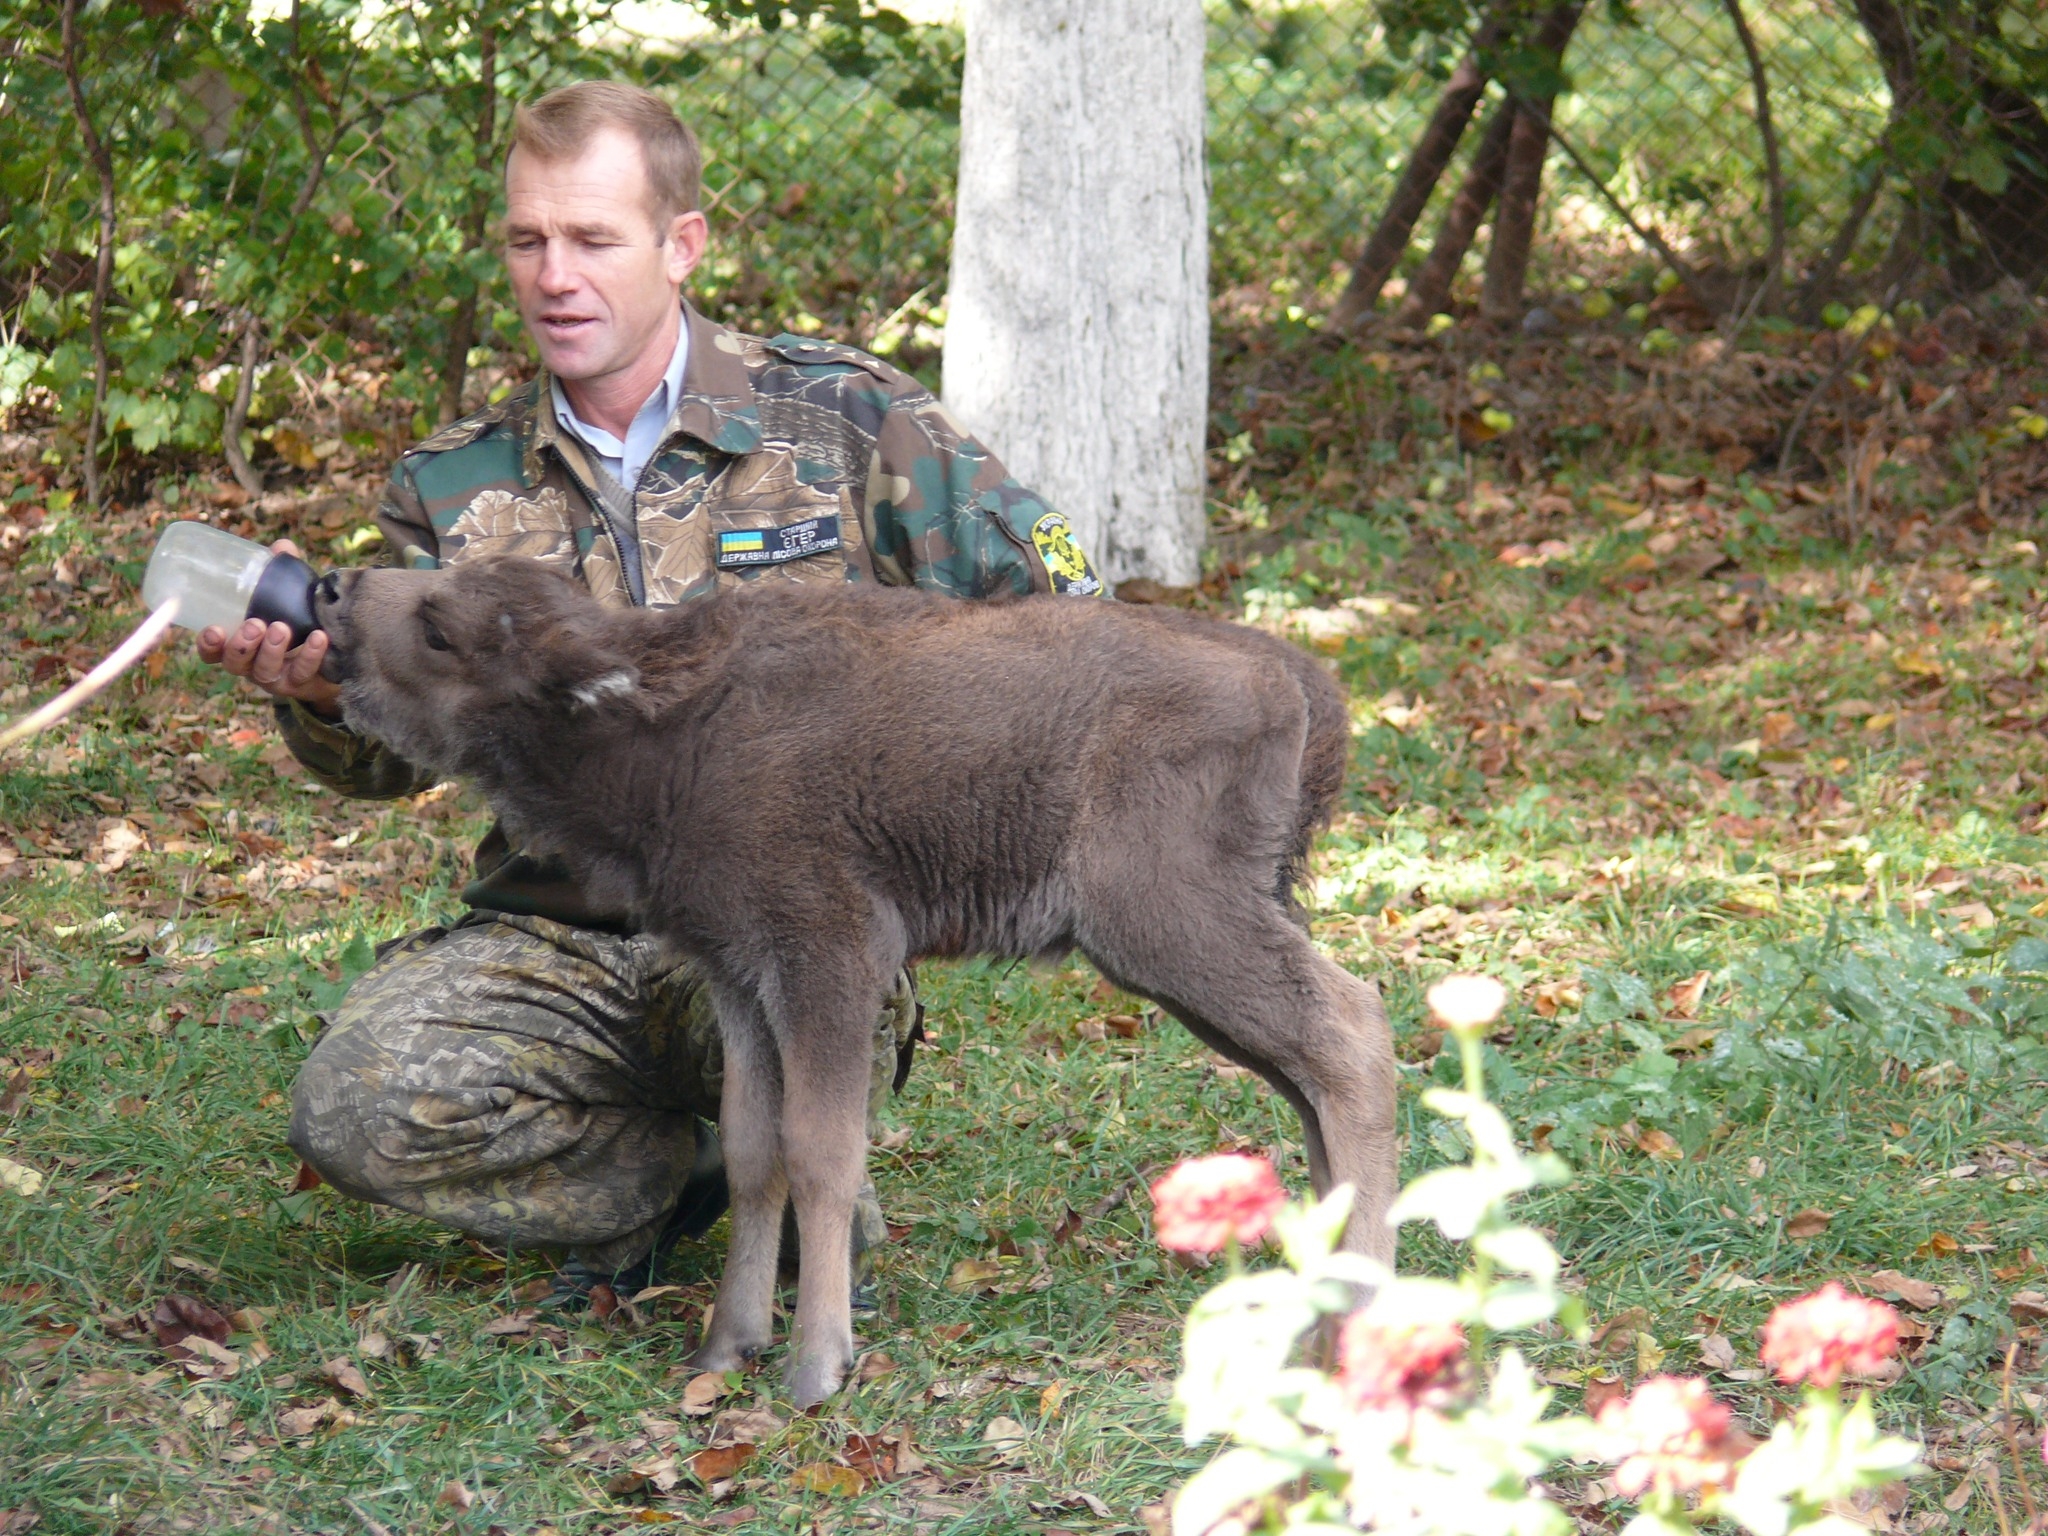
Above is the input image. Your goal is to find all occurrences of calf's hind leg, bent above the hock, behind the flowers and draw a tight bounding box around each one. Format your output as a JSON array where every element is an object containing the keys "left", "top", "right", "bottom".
[{"left": 1085, "top": 901, "right": 1397, "bottom": 1266}]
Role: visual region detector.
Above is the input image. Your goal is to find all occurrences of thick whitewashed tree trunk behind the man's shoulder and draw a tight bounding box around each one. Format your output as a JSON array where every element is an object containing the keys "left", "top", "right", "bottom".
[{"left": 942, "top": 0, "right": 1208, "bottom": 586}]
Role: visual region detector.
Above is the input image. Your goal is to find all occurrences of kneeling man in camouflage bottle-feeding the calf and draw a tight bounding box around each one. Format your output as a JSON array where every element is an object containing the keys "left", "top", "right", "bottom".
[{"left": 199, "top": 82, "right": 1102, "bottom": 1296}]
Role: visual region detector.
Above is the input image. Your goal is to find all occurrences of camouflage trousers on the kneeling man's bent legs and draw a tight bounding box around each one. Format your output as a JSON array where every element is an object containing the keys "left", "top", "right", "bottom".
[{"left": 291, "top": 911, "right": 918, "bottom": 1272}]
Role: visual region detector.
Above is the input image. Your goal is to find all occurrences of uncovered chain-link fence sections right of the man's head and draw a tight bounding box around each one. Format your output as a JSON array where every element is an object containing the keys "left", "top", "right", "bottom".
[{"left": 667, "top": 0, "right": 1896, "bottom": 346}]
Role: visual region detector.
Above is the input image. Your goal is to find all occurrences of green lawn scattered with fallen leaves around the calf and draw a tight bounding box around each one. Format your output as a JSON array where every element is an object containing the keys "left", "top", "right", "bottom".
[{"left": 0, "top": 376, "right": 2048, "bottom": 1534}]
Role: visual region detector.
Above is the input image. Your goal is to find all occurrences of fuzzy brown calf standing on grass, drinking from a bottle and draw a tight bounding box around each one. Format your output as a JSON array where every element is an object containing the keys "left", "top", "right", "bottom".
[{"left": 317, "top": 559, "right": 1395, "bottom": 1403}]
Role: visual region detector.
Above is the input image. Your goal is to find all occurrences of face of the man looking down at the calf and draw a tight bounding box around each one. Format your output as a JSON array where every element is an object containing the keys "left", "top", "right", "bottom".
[{"left": 506, "top": 129, "right": 705, "bottom": 383}]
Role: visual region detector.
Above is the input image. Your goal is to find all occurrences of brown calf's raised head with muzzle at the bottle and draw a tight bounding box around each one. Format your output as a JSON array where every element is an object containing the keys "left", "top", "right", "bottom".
[{"left": 313, "top": 557, "right": 639, "bottom": 778}]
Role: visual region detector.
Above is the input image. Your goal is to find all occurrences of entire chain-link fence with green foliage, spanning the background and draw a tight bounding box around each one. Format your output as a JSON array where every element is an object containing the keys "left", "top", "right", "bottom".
[{"left": 0, "top": 0, "right": 1998, "bottom": 493}]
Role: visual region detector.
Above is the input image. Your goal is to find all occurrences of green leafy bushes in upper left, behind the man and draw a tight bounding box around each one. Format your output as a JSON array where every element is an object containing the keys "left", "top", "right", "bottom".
[{"left": 0, "top": 0, "right": 604, "bottom": 502}]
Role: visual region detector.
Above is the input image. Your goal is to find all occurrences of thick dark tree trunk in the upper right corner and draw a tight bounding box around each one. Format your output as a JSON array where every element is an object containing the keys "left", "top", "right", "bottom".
[{"left": 1855, "top": 0, "right": 2048, "bottom": 287}]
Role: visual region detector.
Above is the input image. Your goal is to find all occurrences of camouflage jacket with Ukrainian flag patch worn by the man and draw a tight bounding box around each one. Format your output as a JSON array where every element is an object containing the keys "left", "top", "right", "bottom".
[{"left": 279, "top": 305, "right": 1102, "bottom": 928}]
